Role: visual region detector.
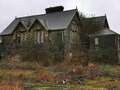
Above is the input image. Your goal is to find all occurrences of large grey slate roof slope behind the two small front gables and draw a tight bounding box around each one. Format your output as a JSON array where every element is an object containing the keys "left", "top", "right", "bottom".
[{"left": 1, "top": 9, "right": 77, "bottom": 35}]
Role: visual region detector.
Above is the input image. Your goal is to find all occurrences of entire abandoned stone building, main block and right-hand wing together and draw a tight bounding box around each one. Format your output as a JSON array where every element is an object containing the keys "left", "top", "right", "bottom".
[{"left": 0, "top": 6, "right": 120, "bottom": 61}]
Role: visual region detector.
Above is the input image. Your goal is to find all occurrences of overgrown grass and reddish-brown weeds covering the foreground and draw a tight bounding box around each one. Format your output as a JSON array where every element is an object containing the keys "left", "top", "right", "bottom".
[{"left": 0, "top": 62, "right": 120, "bottom": 90}]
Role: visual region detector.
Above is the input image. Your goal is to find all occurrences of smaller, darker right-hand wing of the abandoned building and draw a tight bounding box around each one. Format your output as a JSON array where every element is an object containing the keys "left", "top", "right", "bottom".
[{"left": 83, "top": 15, "right": 120, "bottom": 63}]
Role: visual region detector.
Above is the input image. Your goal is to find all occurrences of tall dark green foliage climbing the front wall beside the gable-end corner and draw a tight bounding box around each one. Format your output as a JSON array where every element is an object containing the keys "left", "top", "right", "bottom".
[{"left": 49, "top": 32, "right": 64, "bottom": 64}]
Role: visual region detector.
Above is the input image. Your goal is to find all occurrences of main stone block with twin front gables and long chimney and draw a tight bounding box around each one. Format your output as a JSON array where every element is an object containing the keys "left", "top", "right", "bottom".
[{"left": 1, "top": 6, "right": 80, "bottom": 61}]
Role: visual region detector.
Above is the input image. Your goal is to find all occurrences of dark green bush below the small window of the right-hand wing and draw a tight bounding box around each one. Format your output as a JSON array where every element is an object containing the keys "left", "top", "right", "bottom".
[{"left": 88, "top": 48, "right": 118, "bottom": 64}]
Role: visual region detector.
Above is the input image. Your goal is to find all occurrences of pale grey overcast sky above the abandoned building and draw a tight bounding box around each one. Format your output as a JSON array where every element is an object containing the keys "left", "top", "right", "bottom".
[{"left": 0, "top": 0, "right": 120, "bottom": 33}]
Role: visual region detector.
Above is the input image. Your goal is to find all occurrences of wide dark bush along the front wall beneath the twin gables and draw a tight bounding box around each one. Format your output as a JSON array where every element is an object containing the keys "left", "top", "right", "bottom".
[{"left": 6, "top": 41, "right": 63, "bottom": 66}]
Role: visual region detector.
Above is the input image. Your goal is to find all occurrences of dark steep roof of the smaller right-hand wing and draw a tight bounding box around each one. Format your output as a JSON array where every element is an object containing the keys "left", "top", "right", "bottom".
[{"left": 81, "top": 16, "right": 109, "bottom": 34}]
